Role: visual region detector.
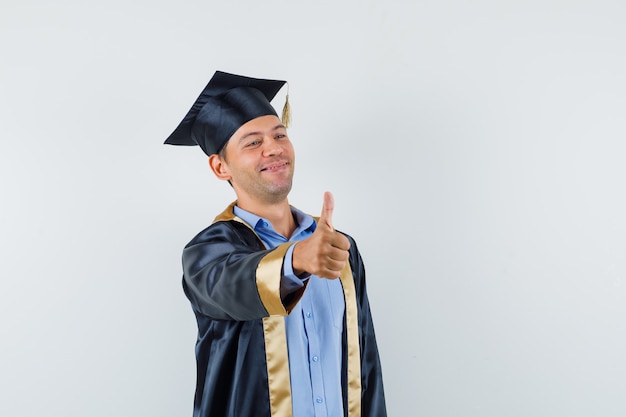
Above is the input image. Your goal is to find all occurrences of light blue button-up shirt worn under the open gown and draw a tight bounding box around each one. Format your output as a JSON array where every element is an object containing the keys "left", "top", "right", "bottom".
[{"left": 234, "top": 206, "right": 345, "bottom": 417}]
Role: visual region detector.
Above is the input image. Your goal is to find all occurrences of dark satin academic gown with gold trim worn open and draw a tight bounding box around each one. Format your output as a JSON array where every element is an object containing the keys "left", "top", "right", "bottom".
[{"left": 183, "top": 203, "right": 387, "bottom": 417}]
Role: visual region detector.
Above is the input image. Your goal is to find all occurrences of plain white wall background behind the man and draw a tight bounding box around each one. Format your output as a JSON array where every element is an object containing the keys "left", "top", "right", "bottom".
[{"left": 0, "top": 0, "right": 626, "bottom": 417}]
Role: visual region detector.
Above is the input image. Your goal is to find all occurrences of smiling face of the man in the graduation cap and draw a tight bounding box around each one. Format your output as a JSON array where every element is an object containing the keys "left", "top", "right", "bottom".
[{"left": 217, "top": 115, "right": 295, "bottom": 203}]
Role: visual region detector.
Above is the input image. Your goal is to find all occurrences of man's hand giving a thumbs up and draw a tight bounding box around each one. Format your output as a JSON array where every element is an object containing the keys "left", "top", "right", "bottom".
[{"left": 292, "top": 192, "right": 350, "bottom": 279}]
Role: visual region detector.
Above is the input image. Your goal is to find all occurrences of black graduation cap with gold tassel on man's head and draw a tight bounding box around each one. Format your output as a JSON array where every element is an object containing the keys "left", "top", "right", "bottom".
[{"left": 165, "top": 71, "right": 289, "bottom": 155}]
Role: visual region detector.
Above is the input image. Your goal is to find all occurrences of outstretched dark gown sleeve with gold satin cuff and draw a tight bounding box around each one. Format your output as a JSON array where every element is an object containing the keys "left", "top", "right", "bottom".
[{"left": 183, "top": 221, "right": 304, "bottom": 321}]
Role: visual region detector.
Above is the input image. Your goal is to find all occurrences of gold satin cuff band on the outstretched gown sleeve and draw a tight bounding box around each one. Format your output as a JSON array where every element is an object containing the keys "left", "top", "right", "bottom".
[{"left": 256, "top": 242, "right": 295, "bottom": 316}]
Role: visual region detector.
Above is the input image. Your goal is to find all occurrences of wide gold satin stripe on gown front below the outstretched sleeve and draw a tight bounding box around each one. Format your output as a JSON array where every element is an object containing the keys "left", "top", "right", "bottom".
[{"left": 263, "top": 317, "right": 293, "bottom": 417}]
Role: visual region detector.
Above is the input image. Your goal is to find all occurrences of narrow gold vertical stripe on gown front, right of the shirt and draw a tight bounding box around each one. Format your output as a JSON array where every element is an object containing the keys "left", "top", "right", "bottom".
[{"left": 339, "top": 262, "right": 361, "bottom": 417}]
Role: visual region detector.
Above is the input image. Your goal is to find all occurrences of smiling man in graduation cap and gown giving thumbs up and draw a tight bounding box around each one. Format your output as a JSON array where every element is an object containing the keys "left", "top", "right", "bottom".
[{"left": 165, "top": 71, "right": 386, "bottom": 417}]
